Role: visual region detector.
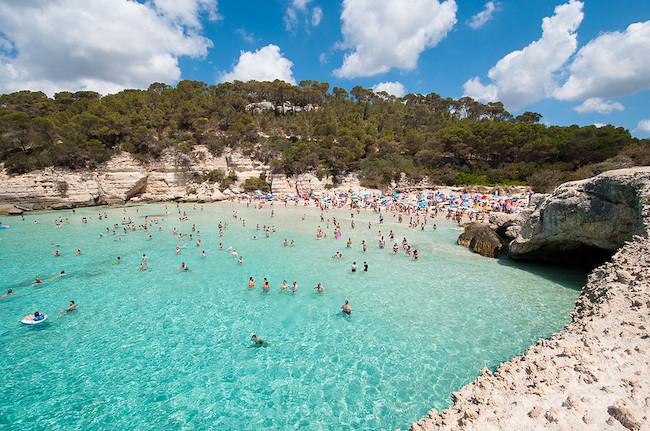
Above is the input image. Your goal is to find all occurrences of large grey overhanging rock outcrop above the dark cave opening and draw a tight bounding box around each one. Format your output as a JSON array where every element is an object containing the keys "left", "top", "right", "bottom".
[{"left": 509, "top": 167, "right": 650, "bottom": 261}]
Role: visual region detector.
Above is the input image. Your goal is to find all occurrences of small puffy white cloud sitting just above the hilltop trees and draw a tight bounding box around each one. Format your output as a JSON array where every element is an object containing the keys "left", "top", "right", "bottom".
[{"left": 221, "top": 45, "right": 296, "bottom": 84}]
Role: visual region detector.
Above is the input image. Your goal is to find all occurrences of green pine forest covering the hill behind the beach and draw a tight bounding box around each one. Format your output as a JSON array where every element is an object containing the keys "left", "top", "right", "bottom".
[{"left": 0, "top": 81, "right": 650, "bottom": 190}]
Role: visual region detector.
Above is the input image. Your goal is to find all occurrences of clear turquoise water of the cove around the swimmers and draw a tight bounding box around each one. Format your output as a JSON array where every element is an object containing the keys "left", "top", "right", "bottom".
[{"left": 0, "top": 204, "right": 583, "bottom": 430}]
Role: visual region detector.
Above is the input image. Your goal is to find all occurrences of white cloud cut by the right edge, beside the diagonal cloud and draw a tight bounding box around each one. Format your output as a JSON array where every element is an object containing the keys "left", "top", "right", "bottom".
[{"left": 554, "top": 21, "right": 650, "bottom": 100}]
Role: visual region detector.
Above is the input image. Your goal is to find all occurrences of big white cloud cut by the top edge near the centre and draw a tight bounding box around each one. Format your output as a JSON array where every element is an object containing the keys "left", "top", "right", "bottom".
[{"left": 334, "top": 0, "right": 457, "bottom": 78}]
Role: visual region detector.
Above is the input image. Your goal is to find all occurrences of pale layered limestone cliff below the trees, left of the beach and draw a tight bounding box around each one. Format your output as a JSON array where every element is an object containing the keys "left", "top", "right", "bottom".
[{"left": 0, "top": 145, "right": 378, "bottom": 213}]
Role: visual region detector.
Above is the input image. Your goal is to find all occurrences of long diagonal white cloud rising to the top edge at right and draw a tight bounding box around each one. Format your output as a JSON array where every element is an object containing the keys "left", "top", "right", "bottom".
[{"left": 465, "top": 0, "right": 584, "bottom": 110}]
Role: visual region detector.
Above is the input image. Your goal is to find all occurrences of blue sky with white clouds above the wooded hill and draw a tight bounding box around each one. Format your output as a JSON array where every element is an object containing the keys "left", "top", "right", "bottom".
[{"left": 0, "top": 0, "right": 650, "bottom": 137}]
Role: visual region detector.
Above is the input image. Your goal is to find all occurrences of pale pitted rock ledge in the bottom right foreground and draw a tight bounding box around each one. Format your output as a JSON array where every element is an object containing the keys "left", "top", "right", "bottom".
[{"left": 411, "top": 237, "right": 650, "bottom": 431}]
